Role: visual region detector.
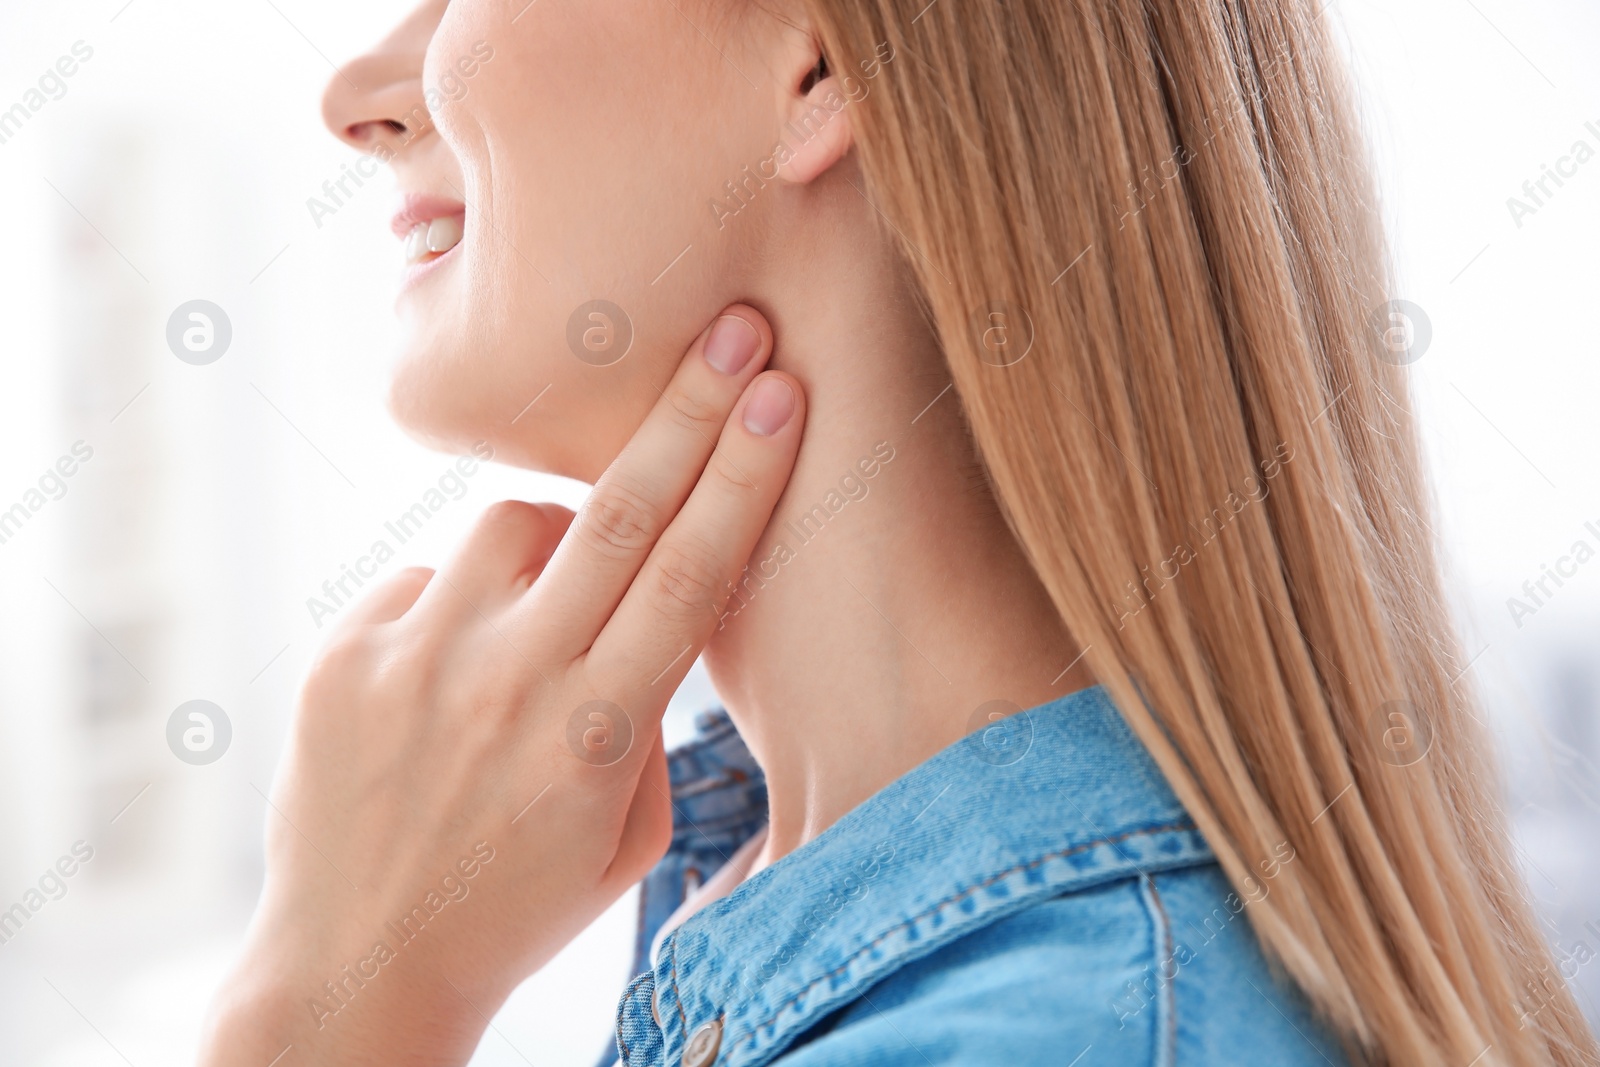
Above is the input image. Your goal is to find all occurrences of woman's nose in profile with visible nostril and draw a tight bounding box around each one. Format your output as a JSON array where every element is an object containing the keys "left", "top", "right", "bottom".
[{"left": 322, "top": 0, "right": 448, "bottom": 160}]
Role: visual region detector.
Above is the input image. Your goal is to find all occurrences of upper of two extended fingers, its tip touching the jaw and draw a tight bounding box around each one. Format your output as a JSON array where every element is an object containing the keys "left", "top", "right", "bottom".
[{"left": 517, "top": 304, "right": 773, "bottom": 661}]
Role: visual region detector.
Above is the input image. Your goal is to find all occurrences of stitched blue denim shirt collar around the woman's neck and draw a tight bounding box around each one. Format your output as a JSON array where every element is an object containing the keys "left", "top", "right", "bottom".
[{"left": 654, "top": 686, "right": 1211, "bottom": 1067}]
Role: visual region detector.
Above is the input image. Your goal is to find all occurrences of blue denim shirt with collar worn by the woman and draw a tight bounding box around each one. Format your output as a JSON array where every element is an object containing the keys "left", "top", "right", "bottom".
[{"left": 604, "top": 686, "right": 1349, "bottom": 1067}]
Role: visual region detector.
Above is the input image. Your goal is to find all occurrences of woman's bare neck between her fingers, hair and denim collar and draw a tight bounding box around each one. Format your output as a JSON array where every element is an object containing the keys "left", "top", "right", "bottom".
[{"left": 706, "top": 177, "right": 1091, "bottom": 869}]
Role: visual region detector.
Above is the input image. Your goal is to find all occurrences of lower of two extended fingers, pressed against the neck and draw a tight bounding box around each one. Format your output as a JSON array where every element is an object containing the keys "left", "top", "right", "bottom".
[{"left": 584, "top": 371, "right": 805, "bottom": 707}]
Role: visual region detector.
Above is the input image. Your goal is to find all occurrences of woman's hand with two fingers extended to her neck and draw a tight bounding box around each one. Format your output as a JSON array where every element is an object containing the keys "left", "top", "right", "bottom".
[{"left": 200, "top": 306, "right": 805, "bottom": 1067}]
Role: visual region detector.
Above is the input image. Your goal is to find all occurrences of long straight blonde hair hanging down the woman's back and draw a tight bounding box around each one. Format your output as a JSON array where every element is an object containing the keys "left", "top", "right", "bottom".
[{"left": 810, "top": 0, "right": 1600, "bottom": 1067}]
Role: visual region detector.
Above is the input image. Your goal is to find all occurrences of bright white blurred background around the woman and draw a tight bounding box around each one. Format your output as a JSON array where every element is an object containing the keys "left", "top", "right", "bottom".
[{"left": 0, "top": 0, "right": 1600, "bottom": 1067}]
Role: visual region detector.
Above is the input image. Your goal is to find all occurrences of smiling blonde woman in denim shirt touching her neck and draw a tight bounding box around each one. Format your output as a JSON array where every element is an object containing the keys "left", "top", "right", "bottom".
[{"left": 203, "top": 0, "right": 1597, "bottom": 1067}]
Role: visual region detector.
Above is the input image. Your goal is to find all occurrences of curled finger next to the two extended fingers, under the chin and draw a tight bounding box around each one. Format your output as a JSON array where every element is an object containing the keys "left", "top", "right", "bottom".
[{"left": 413, "top": 501, "right": 573, "bottom": 625}]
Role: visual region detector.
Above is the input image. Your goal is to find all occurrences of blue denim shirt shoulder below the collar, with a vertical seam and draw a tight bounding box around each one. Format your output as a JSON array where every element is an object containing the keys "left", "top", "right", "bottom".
[{"left": 779, "top": 864, "right": 1346, "bottom": 1067}]
